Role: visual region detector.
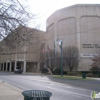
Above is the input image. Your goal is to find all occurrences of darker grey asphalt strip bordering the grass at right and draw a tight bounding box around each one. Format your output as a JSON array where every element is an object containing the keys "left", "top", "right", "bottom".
[{"left": 49, "top": 78, "right": 100, "bottom": 92}]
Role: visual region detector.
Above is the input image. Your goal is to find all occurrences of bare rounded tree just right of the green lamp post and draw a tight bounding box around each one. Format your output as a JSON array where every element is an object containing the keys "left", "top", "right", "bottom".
[{"left": 63, "top": 46, "right": 79, "bottom": 71}]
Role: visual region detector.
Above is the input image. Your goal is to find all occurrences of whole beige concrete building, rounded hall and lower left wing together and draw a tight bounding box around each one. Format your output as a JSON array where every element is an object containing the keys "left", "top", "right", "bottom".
[{"left": 0, "top": 4, "right": 100, "bottom": 72}]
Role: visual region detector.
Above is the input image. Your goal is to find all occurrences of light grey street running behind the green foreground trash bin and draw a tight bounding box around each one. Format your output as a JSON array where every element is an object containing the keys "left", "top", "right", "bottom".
[{"left": 0, "top": 72, "right": 98, "bottom": 100}]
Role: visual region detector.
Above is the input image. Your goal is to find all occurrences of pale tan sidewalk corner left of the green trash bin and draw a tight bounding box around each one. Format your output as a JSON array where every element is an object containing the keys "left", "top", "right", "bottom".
[{"left": 0, "top": 80, "right": 24, "bottom": 100}]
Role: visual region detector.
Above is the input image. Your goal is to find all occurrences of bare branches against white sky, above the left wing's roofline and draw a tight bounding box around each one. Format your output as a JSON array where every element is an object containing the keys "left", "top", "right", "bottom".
[{"left": 0, "top": 0, "right": 33, "bottom": 39}]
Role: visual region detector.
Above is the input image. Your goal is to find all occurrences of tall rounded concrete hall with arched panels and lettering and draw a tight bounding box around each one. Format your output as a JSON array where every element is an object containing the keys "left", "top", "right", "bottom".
[{"left": 46, "top": 4, "right": 100, "bottom": 71}]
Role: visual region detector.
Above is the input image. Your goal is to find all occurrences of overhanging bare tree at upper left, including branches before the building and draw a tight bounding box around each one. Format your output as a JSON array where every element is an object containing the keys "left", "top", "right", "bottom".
[{"left": 0, "top": 0, "right": 43, "bottom": 53}]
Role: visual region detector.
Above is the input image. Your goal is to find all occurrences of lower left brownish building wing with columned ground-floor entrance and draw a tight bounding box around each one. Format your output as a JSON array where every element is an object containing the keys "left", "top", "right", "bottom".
[{"left": 0, "top": 26, "right": 45, "bottom": 73}]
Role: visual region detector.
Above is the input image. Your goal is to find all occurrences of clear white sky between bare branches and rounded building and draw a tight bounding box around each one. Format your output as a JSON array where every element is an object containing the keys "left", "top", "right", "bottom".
[{"left": 22, "top": 0, "right": 100, "bottom": 30}]
